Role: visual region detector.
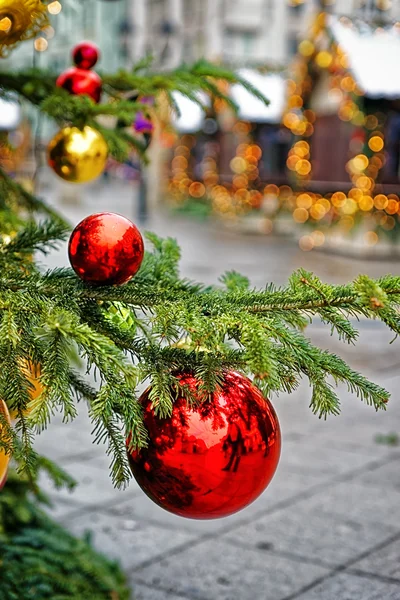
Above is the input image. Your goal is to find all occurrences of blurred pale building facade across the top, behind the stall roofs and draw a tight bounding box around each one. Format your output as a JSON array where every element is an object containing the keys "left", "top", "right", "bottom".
[{"left": 3, "top": 0, "right": 400, "bottom": 70}]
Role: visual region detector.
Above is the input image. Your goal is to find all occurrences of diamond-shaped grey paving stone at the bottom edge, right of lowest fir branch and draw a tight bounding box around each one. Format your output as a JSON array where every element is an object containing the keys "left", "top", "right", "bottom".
[{"left": 137, "top": 540, "right": 329, "bottom": 600}]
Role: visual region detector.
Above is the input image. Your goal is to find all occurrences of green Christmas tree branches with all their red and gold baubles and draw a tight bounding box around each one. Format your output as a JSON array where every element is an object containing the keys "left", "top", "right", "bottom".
[{"left": 0, "top": 0, "right": 400, "bottom": 600}]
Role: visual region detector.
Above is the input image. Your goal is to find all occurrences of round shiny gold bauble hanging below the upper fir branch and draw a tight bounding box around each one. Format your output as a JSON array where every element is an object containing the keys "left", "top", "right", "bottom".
[{"left": 48, "top": 125, "right": 108, "bottom": 183}]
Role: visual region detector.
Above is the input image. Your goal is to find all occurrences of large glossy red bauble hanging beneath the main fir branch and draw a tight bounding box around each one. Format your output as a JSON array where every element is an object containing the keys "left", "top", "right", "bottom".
[{"left": 128, "top": 372, "right": 281, "bottom": 519}]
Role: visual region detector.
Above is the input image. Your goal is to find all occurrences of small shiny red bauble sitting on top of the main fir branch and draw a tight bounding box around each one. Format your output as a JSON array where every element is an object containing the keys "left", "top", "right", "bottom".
[{"left": 68, "top": 213, "right": 144, "bottom": 285}]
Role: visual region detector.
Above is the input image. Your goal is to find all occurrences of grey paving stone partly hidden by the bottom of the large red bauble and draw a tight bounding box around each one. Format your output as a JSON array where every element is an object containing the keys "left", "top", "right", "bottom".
[{"left": 107, "top": 465, "right": 320, "bottom": 535}]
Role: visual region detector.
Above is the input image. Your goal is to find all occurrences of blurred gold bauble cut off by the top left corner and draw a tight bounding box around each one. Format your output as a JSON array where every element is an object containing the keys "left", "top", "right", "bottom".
[{"left": 0, "top": 0, "right": 49, "bottom": 57}]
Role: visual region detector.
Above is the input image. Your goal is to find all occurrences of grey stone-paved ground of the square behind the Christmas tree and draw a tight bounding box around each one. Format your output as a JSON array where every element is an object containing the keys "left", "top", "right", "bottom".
[{"left": 37, "top": 176, "right": 400, "bottom": 600}]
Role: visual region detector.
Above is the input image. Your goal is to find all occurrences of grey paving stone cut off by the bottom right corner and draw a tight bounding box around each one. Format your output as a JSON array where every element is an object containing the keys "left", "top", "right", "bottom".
[{"left": 296, "top": 573, "right": 400, "bottom": 600}]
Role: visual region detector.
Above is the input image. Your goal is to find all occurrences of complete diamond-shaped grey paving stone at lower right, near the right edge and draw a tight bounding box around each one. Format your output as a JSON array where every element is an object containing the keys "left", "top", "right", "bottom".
[{"left": 223, "top": 501, "right": 393, "bottom": 567}]
